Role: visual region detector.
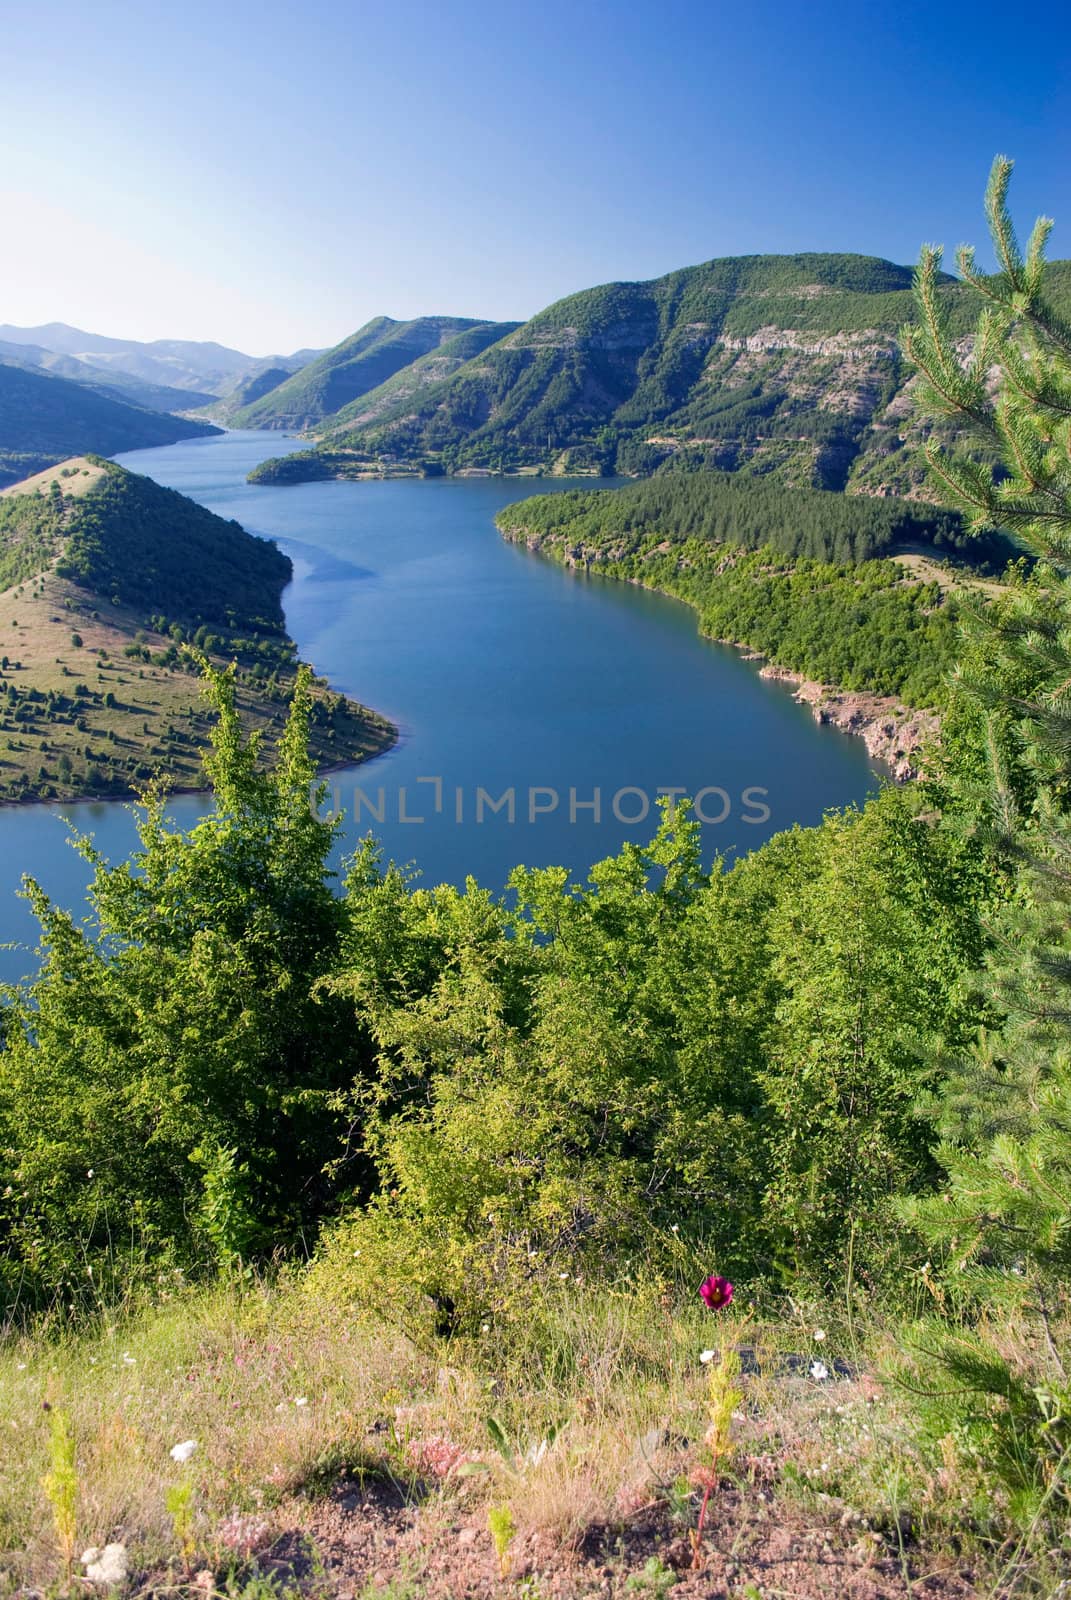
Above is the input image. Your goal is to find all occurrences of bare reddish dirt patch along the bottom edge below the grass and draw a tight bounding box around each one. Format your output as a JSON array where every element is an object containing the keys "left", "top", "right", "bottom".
[{"left": 241, "top": 1478, "right": 978, "bottom": 1600}]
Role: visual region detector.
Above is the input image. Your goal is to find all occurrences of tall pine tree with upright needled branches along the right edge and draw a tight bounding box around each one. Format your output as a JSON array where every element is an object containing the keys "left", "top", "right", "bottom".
[{"left": 903, "top": 157, "right": 1071, "bottom": 1531}]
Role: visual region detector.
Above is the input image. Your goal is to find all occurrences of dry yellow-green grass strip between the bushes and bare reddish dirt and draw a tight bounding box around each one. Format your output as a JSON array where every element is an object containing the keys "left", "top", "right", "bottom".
[{"left": 0, "top": 1275, "right": 1037, "bottom": 1592}]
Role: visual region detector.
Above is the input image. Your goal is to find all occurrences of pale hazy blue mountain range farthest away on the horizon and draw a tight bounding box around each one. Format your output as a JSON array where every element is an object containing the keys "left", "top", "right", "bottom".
[{"left": 0, "top": 322, "right": 319, "bottom": 405}]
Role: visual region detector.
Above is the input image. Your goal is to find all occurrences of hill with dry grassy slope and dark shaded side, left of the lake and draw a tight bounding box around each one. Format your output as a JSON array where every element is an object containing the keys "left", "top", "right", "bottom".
[{"left": 0, "top": 460, "right": 394, "bottom": 800}]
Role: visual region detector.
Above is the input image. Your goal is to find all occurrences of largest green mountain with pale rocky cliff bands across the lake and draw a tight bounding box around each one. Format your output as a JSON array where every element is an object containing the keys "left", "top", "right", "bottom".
[{"left": 258, "top": 254, "right": 1071, "bottom": 494}]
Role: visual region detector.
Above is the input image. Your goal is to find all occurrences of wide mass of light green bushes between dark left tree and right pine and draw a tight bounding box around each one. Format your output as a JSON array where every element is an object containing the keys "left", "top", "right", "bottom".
[{"left": 310, "top": 790, "right": 980, "bottom": 1338}]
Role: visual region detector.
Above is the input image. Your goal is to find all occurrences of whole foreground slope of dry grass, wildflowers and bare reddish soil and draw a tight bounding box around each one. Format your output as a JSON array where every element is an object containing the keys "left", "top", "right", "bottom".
[{"left": 0, "top": 1277, "right": 1004, "bottom": 1600}]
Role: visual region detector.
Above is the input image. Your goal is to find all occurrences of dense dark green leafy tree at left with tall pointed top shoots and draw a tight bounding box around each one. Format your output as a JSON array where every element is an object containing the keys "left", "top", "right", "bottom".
[{"left": 0, "top": 669, "right": 363, "bottom": 1304}]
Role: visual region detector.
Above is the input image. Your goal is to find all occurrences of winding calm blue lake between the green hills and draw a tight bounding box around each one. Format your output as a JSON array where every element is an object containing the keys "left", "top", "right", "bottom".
[{"left": 0, "top": 432, "right": 879, "bottom": 979}]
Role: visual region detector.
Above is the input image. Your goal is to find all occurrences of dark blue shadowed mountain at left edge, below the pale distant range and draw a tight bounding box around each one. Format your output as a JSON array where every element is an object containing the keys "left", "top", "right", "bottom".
[{"left": 0, "top": 365, "right": 219, "bottom": 486}]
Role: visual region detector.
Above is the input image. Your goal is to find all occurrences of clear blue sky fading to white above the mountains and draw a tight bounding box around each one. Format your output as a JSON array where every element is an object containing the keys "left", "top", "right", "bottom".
[{"left": 0, "top": 0, "right": 1071, "bottom": 355}]
